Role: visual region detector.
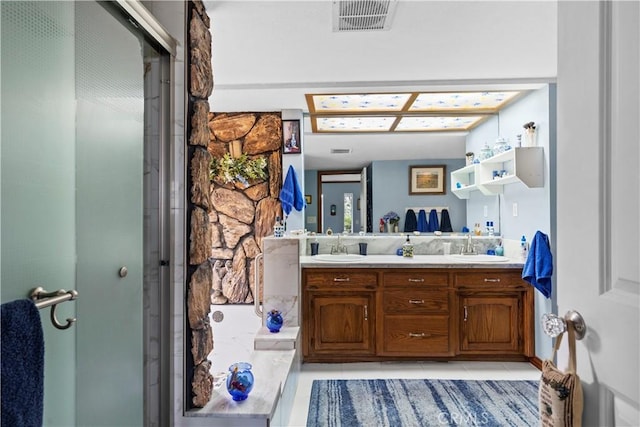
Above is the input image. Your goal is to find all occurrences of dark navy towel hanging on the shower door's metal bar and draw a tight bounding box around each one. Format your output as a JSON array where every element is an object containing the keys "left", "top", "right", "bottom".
[{"left": 0, "top": 299, "right": 44, "bottom": 426}]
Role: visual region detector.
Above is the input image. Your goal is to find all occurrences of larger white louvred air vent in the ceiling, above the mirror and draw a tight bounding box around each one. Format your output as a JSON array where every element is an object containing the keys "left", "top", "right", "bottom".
[{"left": 333, "top": 0, "right": 398, "bottom": 32}]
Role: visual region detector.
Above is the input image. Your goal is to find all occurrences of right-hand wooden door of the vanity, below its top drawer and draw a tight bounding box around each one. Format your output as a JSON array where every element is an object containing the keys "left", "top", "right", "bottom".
[{"left": 460, "top": 292, "right": 522, "bottom": 354}]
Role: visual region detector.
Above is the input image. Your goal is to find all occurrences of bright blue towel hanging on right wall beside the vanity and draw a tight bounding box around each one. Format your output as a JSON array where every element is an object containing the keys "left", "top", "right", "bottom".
[{"left": 522, "top": 231, "right": 553, "bottom": 298}]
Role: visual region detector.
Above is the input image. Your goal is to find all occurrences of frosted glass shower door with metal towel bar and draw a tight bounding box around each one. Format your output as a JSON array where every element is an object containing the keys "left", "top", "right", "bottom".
[{"left": 0, "top": 1, "right": 160, "bottom": 426}]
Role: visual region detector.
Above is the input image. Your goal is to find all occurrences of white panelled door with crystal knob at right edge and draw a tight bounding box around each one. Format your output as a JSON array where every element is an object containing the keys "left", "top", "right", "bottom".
[{"left": 556, "top": 1, "right": 640, "bottom": 426}]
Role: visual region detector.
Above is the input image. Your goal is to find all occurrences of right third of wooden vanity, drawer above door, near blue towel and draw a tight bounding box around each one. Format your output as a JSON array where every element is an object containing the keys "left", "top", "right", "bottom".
[{"left": 454, "top": 270, "right": 535, "bottom": 357}]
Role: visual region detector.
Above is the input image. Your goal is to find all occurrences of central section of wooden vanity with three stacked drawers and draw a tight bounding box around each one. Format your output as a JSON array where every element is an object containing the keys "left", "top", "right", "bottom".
[{"left": 378, "top": 269, "right": 454, "bottom": 357}]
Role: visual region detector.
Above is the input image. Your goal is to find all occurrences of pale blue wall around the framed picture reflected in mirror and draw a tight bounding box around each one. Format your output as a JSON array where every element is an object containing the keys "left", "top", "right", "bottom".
[{"left": 372, "top": 159, "right": 467, "bottom": 232}]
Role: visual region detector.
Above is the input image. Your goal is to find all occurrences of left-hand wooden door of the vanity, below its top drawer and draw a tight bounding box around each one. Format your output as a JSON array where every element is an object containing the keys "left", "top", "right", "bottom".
[{"left": 309, "top": 292, "right": 375, "bottom": 355}]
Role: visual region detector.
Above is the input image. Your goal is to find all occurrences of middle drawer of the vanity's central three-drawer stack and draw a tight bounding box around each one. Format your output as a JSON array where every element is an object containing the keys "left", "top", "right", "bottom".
[{"left": 382, "top": 289, "right": 449, "bottom": 314}]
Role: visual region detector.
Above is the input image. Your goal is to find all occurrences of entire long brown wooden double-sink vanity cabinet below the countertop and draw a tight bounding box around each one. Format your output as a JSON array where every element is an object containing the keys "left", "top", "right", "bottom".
[{"left": 301, "top": 268, "right": 535, "bottom": 362}]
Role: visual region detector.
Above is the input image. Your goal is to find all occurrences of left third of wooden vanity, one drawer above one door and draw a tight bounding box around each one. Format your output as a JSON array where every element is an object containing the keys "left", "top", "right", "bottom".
[{"left": 302, "top": 269, "right": 378, "bottom": 361}]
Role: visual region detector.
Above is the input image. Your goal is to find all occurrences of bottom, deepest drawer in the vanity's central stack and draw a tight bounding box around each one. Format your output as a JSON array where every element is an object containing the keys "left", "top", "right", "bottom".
[{"left": 383, "top": 316, "right": 449, "bottom": 356}]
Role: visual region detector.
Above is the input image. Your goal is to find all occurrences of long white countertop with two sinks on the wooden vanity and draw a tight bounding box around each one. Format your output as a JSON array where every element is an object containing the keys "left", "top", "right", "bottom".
[{"left": 300, "top": 255, "right": 524, "bottom": 268}]
